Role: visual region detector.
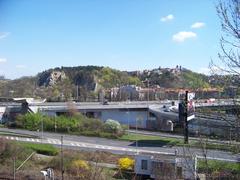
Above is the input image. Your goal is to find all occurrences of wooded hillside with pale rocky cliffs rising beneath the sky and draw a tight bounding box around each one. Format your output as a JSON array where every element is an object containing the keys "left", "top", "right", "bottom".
[{"left": 0, "top": 66, "right": 218, "bottom": 101}]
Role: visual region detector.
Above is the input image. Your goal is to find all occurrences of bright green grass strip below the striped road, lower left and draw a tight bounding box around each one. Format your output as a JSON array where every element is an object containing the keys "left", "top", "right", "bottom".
[{"left": 19, "top": 142, "right": 58, "bottom": 156}]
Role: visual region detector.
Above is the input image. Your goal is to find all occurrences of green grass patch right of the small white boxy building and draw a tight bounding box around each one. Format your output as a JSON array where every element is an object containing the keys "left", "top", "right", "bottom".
[{"left": 198, "top": 160, "right": 240, "bottom": 175}]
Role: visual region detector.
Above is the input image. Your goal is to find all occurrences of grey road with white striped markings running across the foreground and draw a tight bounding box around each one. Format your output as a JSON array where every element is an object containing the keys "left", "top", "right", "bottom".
[{"left": 0, "top": 128, "right": 240, "bottom": 162}]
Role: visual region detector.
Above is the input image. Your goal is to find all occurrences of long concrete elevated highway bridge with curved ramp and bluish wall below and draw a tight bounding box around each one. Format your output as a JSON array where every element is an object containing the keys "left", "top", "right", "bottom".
[{"left": 0, "top": 98, "right": 238, "bottom": 134}]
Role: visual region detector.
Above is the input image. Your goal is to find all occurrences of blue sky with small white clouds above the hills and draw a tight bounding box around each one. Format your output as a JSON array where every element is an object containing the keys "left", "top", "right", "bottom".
[{"left": 0, "top": 0, "right": 221, "bottom": 79}]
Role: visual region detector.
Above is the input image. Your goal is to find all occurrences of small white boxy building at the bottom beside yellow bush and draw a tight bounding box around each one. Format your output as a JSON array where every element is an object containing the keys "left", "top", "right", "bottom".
[{"left": 134, "top": 154, "right": 197, "bottom": 179}]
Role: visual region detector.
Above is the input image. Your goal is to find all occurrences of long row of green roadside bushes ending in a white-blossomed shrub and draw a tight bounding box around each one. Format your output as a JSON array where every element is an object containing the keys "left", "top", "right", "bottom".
[{"left": 16, "top": 113, "right": 124, "bottom": 138}]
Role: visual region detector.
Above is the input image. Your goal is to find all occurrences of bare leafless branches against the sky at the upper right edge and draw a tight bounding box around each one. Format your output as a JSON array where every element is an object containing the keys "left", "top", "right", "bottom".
[{"left": 216, "top": 0, "right": 240, "bottom": 75}]
